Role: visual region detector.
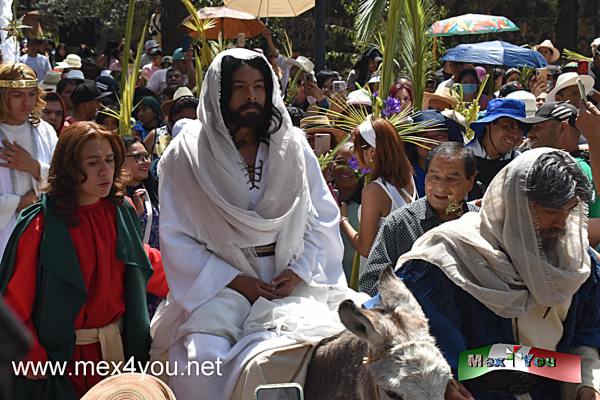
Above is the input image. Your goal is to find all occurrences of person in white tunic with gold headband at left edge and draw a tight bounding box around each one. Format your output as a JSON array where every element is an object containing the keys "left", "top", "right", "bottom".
[{"left": 0, "top": 63, "right": 58, "bottom": 255}]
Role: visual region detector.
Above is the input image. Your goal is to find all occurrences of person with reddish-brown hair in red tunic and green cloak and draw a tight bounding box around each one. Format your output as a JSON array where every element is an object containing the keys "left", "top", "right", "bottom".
[{"left": 0, "top": 122, "right": 167, "bottom": 400}]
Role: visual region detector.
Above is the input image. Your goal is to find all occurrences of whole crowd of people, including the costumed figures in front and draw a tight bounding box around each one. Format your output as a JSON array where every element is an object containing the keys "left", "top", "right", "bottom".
[{"left": 0, "top": 23, "right": 600, "bottom": 400}]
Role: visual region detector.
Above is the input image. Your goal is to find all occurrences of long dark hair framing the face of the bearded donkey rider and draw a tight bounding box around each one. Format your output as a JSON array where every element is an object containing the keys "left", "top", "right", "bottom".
[{"left": 220, "top": 56, "right": 283, "bottom": 143}]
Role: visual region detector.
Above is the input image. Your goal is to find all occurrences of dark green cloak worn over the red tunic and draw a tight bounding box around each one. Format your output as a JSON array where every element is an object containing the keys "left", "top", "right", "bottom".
[{"left": 0, "top": 196, "right": 152, "bottom": 400}]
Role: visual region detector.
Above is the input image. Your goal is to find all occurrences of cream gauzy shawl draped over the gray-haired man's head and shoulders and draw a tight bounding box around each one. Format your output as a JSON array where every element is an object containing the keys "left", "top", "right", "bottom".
[{"left": 397, "top": 148, "right": 591, "bottom": 318}]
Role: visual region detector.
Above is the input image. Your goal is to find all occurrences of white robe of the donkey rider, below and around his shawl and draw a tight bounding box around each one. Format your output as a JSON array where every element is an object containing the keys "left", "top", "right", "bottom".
[{"left": 151, "top": 132, "right": 360, "bottom": 400}]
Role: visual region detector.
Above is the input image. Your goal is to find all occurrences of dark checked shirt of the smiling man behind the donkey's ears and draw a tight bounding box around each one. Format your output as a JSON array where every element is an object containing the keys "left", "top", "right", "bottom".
[{"left": 358, "top": 197, "right": 479, "bottom": 296}]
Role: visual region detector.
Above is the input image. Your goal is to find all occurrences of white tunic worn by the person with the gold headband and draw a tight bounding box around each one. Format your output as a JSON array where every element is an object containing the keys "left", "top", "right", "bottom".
[{"left": 0, "top": 121, "right": 58, "bottom": 254}]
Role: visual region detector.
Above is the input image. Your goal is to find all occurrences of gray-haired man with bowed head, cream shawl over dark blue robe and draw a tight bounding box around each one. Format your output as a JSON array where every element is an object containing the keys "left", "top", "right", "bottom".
[{"left": 366, "top": 148, "right": 600, "bottom": 400}]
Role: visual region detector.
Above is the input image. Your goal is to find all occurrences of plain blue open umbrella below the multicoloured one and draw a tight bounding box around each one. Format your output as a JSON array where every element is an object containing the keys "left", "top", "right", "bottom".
[{"left": 442, "top": 40, "right": 547, "bottom": 68}]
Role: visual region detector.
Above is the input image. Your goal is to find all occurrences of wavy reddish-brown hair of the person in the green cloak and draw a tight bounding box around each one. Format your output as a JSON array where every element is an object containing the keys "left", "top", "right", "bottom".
[{"left": 45, "top": 121, "right": 127, "bottom": 226}]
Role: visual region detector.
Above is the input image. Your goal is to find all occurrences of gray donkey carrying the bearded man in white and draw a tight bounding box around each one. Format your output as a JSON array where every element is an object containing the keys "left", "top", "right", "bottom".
[{"left": 304, "top": 268, "right": 452, "bottom": 400}]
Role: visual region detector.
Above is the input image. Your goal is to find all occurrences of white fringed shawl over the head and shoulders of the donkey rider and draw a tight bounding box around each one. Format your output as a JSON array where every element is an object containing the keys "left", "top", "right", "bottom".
[{"left": 159, "top": 49, "right": 315, "bottom": 278}]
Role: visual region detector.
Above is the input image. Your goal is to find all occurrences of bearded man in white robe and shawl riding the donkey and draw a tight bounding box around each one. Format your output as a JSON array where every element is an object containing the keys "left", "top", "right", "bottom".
[{"left": 152, "top": 49, "right": 348, "bottom": 400}]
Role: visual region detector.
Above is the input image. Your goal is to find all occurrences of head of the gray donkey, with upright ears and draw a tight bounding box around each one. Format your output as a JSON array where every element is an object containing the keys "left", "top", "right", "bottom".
[{"left": 338, "top": 268, "right": 451, "bottom": 400}]
